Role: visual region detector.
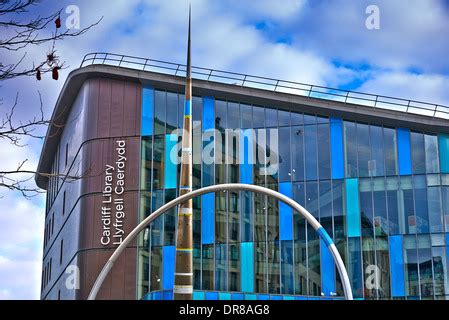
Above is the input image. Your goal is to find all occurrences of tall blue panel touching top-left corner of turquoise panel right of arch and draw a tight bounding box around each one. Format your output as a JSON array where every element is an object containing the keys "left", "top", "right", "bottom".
[{"left": 331, "top": 118, "right": 345, "bottom": 179}]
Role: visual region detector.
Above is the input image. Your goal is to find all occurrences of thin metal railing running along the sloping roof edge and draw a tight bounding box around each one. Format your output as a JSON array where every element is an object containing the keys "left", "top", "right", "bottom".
[{"left": 80, "top": 52, "right": 449, "bottom": 119}]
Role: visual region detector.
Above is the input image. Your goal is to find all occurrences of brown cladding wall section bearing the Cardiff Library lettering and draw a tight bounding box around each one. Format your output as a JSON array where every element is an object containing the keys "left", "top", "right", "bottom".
[{"left": 73, "top": 79, "right": 141, "bottom": 299}]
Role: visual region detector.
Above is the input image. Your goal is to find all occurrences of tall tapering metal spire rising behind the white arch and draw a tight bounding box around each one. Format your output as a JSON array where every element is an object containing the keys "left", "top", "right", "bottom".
[{"left": 173, "top": 4, "right": 193, "bottom": 300}]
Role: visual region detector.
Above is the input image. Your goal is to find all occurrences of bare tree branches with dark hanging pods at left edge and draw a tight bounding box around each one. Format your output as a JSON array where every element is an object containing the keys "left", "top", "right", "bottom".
[{"left": 0, "top": 0, "right": 102, "bottom": 199}]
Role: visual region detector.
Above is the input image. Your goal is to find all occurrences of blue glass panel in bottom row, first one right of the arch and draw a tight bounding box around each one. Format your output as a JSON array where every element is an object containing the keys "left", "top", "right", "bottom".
[{"left": 389, "top": 235, "right": 405, "bottom": 297}]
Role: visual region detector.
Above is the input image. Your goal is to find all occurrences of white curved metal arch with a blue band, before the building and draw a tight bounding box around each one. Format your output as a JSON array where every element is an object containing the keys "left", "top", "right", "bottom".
[{"left": 88, "top": 183, "right": 353, "bottom": 300}]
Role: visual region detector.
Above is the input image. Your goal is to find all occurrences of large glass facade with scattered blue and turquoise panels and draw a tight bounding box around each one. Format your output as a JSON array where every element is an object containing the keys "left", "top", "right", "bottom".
[{"left": 139, "top": 88, "right": 449, "bottom": 299}]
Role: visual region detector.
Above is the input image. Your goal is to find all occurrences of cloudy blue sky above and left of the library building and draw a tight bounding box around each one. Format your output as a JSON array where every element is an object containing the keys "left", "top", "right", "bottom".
[{"left": 0, "top": 0, "right": 449, "bottom": 299}]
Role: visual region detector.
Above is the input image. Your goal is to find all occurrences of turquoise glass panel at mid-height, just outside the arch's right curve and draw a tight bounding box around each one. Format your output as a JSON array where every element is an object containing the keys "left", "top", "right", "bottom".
[{"left": 346, "top": 179, "right": 360, "bottom": 237}]
